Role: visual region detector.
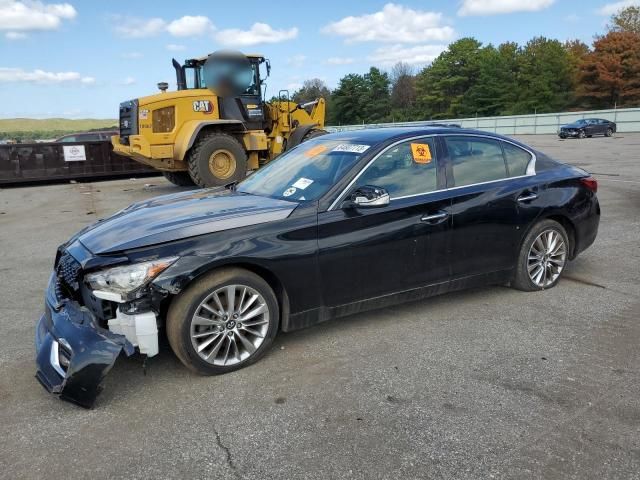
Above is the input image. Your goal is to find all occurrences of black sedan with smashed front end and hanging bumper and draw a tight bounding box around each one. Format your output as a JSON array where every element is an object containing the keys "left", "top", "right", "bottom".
[{"left": 36, "top": 127, "right": 600, "bottom": 406}]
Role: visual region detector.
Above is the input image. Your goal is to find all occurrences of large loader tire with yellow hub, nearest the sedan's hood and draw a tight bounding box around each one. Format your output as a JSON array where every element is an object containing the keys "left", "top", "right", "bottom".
[{"left": 187, "top": 132, "right": 247, "bottom": 188}]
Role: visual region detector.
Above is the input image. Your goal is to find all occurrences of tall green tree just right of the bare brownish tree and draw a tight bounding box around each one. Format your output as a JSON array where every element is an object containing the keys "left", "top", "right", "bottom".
[{"left": 416, "top": 38, "right": 482, "bottom": 118}]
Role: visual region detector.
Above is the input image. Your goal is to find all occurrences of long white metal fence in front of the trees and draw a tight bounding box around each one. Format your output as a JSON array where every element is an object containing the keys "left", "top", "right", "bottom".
[{"left": 327, "top": 108, "right": 640, "bottom": 135}]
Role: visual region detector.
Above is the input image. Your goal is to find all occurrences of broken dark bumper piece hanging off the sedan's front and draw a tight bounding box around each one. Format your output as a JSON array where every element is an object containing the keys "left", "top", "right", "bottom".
[{"left": 36, "top": 276, "right": 134, "bottom": 408}]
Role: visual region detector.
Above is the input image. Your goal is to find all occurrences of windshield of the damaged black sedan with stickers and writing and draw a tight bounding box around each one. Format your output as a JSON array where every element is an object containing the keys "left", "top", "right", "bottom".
[{"left": 237, "top": 139, "right": 371, "bottom": 201}]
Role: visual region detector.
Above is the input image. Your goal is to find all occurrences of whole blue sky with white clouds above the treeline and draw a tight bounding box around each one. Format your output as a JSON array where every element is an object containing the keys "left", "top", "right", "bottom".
[{"left": 0, "top": 0, "right": 640, "bottom": 118}]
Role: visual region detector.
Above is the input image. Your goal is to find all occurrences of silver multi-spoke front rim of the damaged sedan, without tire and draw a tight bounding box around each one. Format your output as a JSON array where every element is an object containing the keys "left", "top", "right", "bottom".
[{"left": 190, "top": 285, "right": 270, "bottom": 366}]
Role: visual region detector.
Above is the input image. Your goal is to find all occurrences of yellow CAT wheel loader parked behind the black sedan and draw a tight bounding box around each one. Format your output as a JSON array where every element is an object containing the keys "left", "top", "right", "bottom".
[{"left": 111, "top": 52, "right": 326, "bottom": 187}]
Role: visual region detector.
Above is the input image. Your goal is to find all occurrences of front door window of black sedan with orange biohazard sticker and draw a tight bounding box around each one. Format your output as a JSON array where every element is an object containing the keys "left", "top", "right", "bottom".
[{"left": 355, "top": 137, "right": 438, "bottom": 200}]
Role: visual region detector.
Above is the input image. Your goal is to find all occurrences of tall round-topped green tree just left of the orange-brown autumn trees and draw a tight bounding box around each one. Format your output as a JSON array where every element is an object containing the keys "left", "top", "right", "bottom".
[{"left": 513, "top": 37, "right": 572, "bottom": 114}]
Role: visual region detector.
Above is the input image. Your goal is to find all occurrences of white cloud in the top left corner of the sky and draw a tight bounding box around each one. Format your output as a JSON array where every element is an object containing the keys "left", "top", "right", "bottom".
[{"left": 0, "top": 0, "right": 78, "bottom": 32}]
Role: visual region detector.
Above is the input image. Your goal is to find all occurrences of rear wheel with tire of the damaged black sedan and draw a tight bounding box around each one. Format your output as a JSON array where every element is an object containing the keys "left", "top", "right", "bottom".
[{"left": 512, "top": 220, "right": 569, "bottom": 292}]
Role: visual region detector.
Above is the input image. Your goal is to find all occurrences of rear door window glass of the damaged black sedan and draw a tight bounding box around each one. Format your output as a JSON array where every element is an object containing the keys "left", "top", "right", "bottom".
[{"left": 445, "top": 137, "right": 508, "bottom": 187}]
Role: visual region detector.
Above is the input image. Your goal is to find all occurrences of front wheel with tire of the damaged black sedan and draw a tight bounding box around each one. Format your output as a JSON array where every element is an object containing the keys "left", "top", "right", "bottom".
[{"left": 167, "top": 268, "right": 280, "bottom": 375}]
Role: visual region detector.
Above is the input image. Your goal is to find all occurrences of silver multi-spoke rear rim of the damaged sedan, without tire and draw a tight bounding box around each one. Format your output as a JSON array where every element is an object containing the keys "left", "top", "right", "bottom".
[{"left": 527, "top": 229, "right": 567, "bottom": 288}]
